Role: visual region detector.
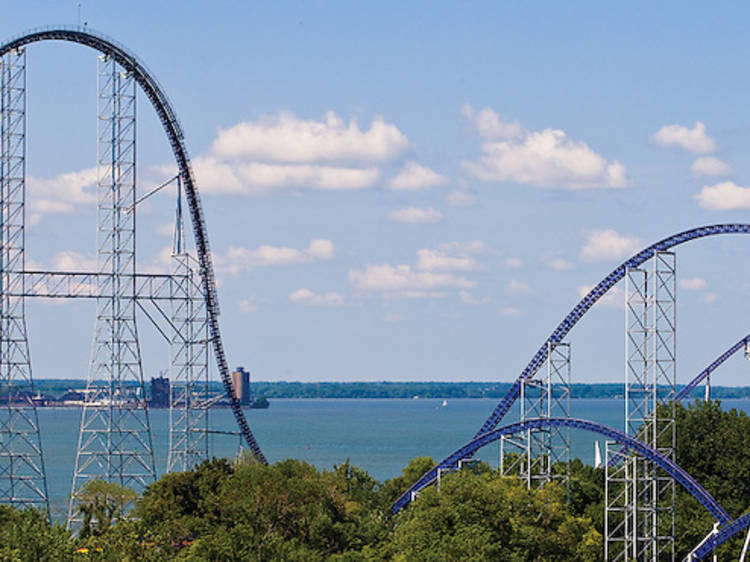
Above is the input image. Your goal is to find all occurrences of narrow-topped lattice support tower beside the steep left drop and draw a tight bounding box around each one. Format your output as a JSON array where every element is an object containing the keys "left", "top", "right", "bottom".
[{"left": 167, "top": 179, "right": 210, "bottom": 472}]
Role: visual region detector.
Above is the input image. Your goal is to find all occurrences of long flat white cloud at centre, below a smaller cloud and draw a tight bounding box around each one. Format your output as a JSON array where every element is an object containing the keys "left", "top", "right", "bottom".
[{"left": 349, "top": 264, "right": 476, "bottom": 296}]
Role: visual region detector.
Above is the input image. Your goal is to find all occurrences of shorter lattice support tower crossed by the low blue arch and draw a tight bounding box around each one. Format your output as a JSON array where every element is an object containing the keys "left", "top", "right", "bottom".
[{"left": 499, "top": 336, "right": 570, "bottom": 489}]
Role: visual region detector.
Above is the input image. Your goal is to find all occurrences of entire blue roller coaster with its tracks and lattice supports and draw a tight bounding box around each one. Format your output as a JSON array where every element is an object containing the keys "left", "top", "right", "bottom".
[{"left": 0, "top": 27, "right": 750, "bottom": 560}]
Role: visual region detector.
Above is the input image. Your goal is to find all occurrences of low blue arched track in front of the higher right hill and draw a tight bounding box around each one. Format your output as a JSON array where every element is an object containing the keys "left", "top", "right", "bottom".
[{"left": 391, "top": 418, "right": 732, "bottom": 525}]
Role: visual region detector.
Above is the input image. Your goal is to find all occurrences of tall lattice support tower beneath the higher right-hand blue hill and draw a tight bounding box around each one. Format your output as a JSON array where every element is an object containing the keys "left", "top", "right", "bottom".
[{"left": 605, "top": 252, "right": 676, "bottom": 560}]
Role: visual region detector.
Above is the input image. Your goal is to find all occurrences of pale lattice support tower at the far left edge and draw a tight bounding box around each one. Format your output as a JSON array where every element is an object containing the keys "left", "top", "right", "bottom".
[{"left": 0, "top": 50, "right": 49, "bottom": 509}]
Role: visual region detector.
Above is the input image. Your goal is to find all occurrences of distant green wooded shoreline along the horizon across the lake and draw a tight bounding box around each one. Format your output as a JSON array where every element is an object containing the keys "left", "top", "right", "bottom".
[{"left": 26, "top": 379, "right": 750, "bottom": 400}]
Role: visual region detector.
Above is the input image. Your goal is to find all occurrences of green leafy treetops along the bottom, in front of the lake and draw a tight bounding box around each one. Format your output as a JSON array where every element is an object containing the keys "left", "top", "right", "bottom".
[{"left": 0, "top": 401, "right": 750, "bottom": 562}]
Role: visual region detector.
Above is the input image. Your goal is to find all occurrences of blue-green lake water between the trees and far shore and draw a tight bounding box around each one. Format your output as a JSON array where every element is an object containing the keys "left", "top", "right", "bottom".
[{"left": 39, "top": 399, "right": 750, "bottom": 519}]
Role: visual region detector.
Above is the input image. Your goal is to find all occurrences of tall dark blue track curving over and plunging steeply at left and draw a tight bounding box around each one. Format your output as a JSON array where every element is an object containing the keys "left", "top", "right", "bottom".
[{"left": 0, "top": 27, "right": 266, "bottom": 463}]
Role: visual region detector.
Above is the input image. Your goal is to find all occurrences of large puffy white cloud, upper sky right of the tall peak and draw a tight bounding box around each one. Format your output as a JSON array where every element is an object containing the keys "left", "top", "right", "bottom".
[{"left": 211, "top": 111, "right": 409, "bottom": 163}]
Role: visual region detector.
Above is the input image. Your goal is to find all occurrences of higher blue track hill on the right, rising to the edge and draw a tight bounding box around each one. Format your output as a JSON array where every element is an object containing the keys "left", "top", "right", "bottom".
[{"left": 399, "top": 223, "right": 750, "bottom": 509}]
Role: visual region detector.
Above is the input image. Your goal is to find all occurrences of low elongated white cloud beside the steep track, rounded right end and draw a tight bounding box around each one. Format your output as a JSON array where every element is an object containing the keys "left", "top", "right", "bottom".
[{"left": 214, "top": 238, "right": 335, "bottom": 274}]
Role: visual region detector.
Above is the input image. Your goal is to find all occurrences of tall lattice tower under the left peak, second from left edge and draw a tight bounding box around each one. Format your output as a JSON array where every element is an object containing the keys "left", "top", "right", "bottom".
[{"left": 68, "top": 55, "right": 156, "bottom": 524}]
